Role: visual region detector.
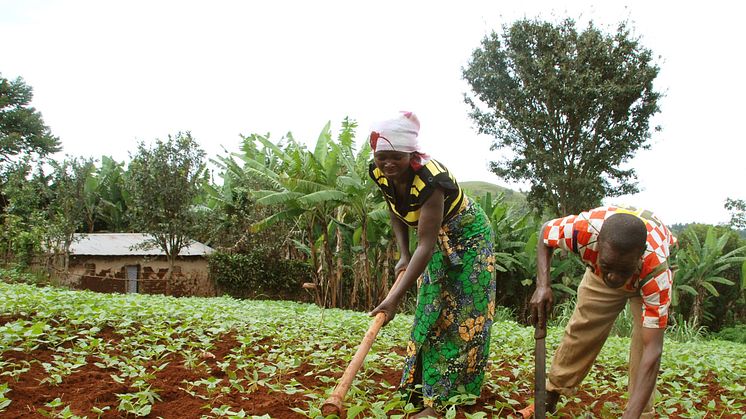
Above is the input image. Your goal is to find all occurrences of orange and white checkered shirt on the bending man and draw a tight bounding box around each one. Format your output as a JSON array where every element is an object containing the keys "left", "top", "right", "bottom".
[{"left": 543, "top": 207, "right": 676, "bottom": 329}]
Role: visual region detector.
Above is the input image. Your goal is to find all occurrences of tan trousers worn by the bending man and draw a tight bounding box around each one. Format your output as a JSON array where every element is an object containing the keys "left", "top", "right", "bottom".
[{"left": 547, "top": 269, "right": 655, "bottom": 418}]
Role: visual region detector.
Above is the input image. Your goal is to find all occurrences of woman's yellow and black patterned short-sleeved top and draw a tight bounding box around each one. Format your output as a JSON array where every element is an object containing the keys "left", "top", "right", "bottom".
[{"left": 368, "top": 160, "right": 464, "bottom": 227}]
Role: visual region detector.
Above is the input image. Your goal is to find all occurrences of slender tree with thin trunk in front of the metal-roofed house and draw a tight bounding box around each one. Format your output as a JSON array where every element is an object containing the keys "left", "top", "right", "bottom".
[{"left": 127, "top": 132, "right": 205, "bottom": 293}]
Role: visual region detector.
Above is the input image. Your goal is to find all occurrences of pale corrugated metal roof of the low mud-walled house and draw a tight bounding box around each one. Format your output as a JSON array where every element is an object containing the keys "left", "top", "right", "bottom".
[{"left": 70, "top": 233, "right": 215, "bottom": 256}]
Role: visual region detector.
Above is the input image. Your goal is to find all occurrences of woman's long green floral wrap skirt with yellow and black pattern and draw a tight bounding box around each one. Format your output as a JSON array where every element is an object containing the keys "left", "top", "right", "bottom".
[{"left": 400, "top": 198, "right": 496, "bottom": 409}]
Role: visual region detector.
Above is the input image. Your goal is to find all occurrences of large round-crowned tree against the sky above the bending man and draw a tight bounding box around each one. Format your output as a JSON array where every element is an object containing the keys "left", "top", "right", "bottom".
[{"left": 463, "top": 19, "right": 661, "bottom": 215}]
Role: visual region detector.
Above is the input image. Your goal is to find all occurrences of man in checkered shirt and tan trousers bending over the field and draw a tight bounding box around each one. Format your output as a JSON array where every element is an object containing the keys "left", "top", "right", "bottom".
[{"left": 531, "top": 207, "right": 676, "bottom": 418}]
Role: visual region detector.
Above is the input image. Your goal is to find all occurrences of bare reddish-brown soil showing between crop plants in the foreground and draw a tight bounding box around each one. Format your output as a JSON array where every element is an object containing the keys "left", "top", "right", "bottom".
[{"left": 0, "top": 318, "right": 738, "bottom": 419}]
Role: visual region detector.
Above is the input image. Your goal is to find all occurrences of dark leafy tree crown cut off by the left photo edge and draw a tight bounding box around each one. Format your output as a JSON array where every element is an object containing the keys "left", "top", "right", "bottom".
[{"left": 0, "top": 74, "right": 60, "bottom": 166}]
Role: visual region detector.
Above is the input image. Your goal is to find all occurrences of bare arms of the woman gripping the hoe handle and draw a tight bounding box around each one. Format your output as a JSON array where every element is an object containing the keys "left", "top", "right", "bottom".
[{"left": 370, "top": 188, "right": 444, "bottom": 324}]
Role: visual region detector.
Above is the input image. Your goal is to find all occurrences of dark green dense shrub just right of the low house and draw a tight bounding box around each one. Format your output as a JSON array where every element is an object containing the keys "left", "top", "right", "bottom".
[{"left": 209, "top": 251, "right": 312, "bottom": 299}]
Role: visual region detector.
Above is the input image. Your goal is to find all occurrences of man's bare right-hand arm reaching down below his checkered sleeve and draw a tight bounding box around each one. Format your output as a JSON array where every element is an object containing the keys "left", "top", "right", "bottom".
[{"left": 623, "top": 327, "right": 665, "bottom": 419}]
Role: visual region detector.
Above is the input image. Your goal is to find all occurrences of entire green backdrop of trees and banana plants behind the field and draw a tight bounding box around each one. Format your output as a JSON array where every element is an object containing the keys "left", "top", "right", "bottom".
[{"left": 0, "top": 19, "right": 746, "bottom": 335}]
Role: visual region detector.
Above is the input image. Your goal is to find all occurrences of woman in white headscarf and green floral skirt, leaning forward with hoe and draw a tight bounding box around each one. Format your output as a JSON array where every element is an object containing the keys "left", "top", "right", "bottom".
[{"left": 369, "top": 112, "right": 495, "bottom": 417}]
